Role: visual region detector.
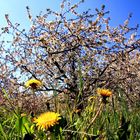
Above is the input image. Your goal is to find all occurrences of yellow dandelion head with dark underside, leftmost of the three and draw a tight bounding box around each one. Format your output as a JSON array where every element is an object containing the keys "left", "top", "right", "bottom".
[{"left": 25, "top": 79, "right": 42, "bottom": 89}]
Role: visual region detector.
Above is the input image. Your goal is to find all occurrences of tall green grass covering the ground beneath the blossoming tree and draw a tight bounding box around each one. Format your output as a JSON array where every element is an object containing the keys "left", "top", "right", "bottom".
[{"left": 0, "top": 85, "right": 140, "bottom": 140}]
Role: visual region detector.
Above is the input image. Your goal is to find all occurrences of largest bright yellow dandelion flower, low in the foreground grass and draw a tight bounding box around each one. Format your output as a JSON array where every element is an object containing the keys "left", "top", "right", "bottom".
[{"left": 34, "top": 112, "right": 61, "bottom": 130}]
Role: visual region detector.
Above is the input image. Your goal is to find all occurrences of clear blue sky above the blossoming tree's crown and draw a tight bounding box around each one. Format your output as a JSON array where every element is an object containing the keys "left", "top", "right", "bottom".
[{"left": 0, "top": 0, "right": 140, "bottom": 28}]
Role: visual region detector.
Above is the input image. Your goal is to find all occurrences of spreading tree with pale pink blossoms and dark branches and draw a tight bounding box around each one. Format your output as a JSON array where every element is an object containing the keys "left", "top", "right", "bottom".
[{"left": 0, "top": 0, "right": 140, "bottom": 111}]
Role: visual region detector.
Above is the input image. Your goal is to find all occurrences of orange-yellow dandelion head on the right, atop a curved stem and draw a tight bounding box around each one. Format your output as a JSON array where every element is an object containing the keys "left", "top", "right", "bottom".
[{"left": 97, "top": 88, "right": 112, "bottom": 97}]
